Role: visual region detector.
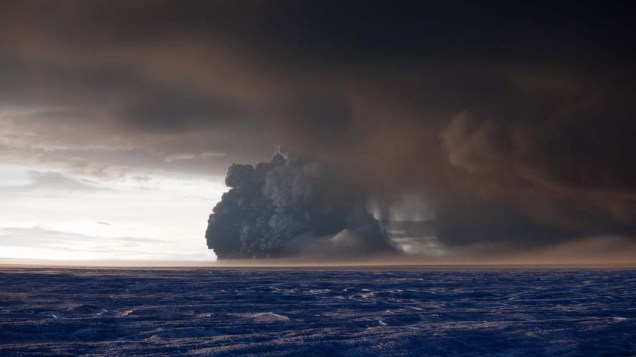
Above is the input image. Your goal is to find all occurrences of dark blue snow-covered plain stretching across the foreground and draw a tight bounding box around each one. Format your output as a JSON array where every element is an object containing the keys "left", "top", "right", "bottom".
[{"left": 0, "top": 268, "right": 636, "bottom": 356}]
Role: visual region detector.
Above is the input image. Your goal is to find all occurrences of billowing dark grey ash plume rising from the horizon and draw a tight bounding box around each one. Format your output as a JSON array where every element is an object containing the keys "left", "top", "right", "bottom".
[{"left": 206, "top": 153, "right": 394, "bottom": 259}]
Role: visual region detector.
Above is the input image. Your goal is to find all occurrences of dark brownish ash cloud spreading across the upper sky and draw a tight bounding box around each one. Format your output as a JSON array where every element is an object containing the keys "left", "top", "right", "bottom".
[{"left": 0, "top": 1, "right": 636, "bottom": 256}]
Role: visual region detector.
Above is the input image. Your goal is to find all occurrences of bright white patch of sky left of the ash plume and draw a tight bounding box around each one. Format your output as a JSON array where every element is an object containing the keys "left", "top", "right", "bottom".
[{"left": 0, "top": 163, "right": 227, "bottom": 261}]
